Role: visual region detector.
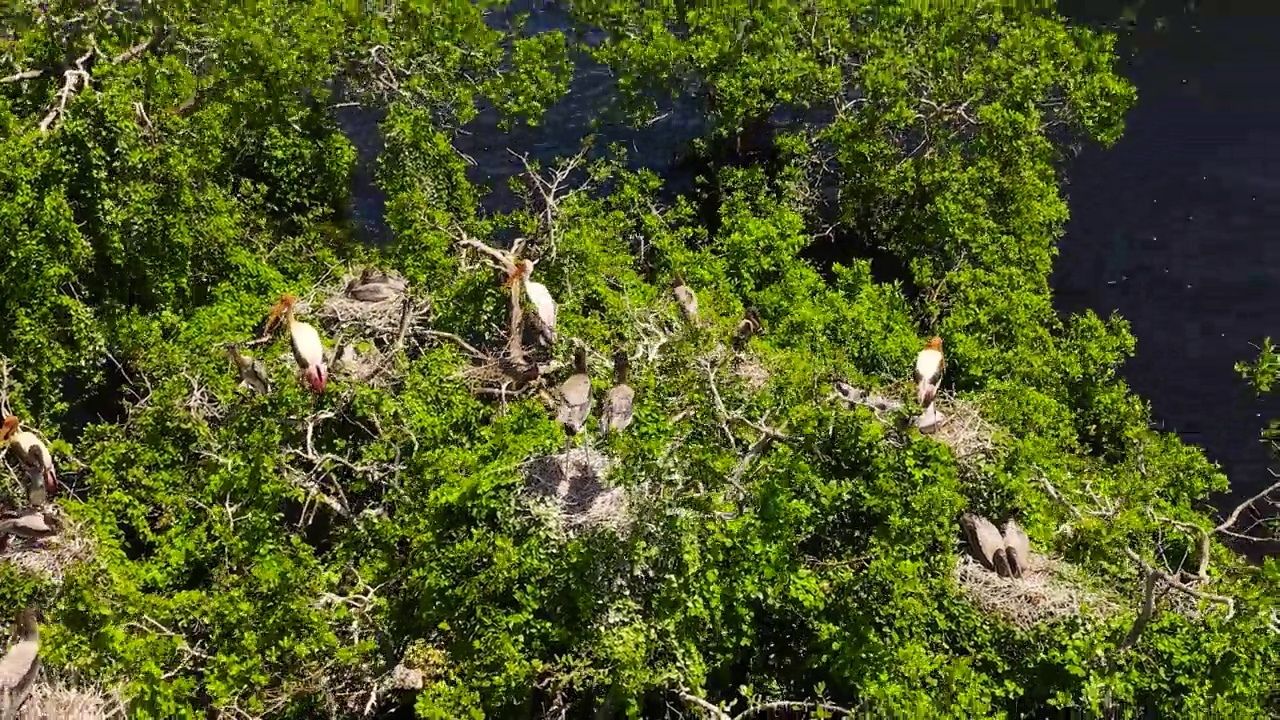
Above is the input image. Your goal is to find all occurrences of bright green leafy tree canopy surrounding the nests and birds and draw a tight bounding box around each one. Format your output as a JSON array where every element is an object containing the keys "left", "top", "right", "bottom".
[{"left": 0, "top": 0, "right": 1280, "bottom": 717}]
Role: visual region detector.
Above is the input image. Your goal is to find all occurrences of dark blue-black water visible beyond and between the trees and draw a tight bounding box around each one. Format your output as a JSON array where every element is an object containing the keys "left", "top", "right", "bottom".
[{"left": 342, "top": 0, "right": 1280, "bottom": 505}]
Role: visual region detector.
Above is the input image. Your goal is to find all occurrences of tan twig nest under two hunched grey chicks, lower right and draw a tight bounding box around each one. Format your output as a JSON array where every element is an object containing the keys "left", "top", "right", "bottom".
[{"left": 955, "top": 552, "right": 1116, "bottom": 629}]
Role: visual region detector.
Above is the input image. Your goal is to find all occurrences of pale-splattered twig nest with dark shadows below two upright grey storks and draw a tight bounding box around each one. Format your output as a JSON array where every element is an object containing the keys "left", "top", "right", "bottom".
[{"left": 525, "top": 448, "right": 632, "bottom": 534}]
